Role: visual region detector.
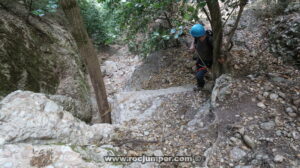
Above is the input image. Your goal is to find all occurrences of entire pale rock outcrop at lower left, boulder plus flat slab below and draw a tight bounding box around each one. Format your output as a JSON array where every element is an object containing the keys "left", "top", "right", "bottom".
[{"left": 0, "top": 91, "right": 162, "bottom": 168}]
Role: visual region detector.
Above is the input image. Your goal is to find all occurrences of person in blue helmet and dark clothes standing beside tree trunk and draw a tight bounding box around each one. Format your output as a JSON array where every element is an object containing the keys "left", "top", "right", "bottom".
[{"left": 190, "top": 24, "right": 213, "bottom": 91}]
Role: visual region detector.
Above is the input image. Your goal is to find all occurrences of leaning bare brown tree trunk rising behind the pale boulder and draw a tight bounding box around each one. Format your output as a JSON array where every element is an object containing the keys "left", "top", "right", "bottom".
[{"left": 59, "top": 0, "right": 111, "bottom": 123}]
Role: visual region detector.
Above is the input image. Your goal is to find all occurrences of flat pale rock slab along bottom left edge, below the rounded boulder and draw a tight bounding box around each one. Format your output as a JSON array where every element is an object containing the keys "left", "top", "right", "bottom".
[{"left": 0, "top": 143, "right": 146, "bottom": 168}]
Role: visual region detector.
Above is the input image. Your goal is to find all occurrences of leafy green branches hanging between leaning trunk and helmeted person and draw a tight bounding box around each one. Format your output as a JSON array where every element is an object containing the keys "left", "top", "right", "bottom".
[{"left": 99, "top": 0, "right": 206, "bottom": 56}]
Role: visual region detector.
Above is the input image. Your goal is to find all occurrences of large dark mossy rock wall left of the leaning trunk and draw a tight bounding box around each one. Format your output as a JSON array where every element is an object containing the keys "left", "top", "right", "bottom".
[{"left": 0, "top": 0, "right": 92, "bottom": 121}]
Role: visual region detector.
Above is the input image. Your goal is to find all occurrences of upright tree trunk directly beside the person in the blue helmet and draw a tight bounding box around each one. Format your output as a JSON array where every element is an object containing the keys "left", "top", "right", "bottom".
[{"left": 206, "top": 0, "right": 226, "bottom": 80}]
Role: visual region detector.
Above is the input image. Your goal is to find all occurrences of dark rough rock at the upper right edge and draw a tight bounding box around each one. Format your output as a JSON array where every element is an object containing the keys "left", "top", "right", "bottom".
[{"left": 270, "top": 4, "right": 300, "bottom": 67}]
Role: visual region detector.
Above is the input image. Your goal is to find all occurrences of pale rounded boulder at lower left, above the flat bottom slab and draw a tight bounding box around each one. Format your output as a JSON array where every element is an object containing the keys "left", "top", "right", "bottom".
[{"left": 0, "top": 91, "right": 113, "bottom": 145}]
